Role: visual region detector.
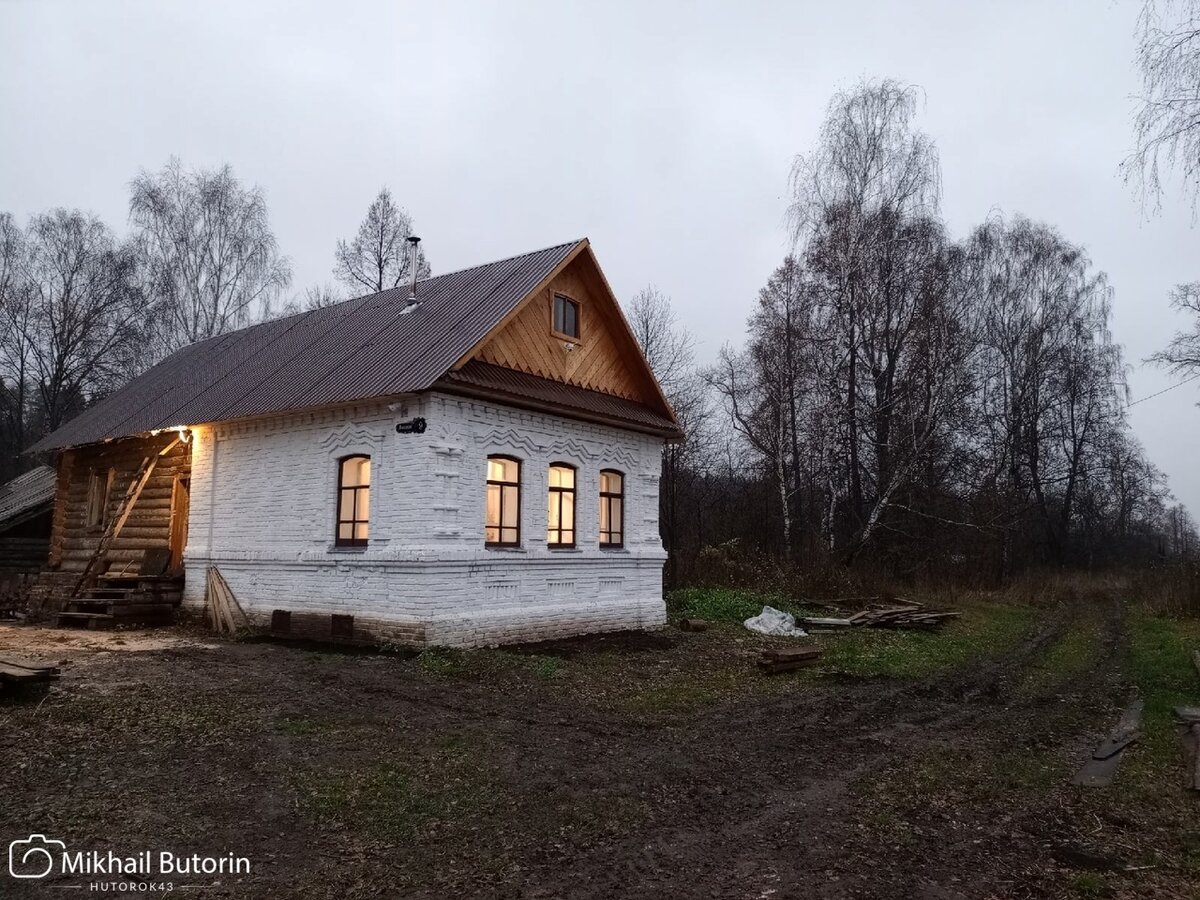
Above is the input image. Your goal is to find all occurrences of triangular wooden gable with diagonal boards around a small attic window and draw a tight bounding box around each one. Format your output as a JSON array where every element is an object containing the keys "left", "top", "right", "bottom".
[{"left": 456, "top": 244, "right": 673, "bottom": 418}]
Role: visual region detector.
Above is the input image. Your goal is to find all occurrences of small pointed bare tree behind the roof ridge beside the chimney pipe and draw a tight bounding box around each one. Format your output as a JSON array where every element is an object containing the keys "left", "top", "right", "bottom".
[{"left": 334, "top": 187, "right": 430, "bottom": 293}]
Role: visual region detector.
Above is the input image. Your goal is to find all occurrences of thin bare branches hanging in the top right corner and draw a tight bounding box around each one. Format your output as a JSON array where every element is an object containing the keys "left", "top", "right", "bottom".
[{"left": 1122, "top": 0, "right": 1200, "bottom": 214}]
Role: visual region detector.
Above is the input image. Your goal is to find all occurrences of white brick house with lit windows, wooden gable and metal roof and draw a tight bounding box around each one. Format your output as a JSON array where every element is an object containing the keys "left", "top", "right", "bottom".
[{"left": 32, "top": 241, "right": 678, "bottom": 647}]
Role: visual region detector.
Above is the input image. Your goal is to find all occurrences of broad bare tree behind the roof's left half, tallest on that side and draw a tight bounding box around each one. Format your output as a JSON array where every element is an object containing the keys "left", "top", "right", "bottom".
[{"left": 130, "top": 158, "right": 292, "bottom": 353}]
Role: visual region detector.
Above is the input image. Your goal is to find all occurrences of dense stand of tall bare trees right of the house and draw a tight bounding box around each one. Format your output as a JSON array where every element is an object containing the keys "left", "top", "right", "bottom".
[{"left": 631, "top": 82, "right": 1198, "bottom": 583}]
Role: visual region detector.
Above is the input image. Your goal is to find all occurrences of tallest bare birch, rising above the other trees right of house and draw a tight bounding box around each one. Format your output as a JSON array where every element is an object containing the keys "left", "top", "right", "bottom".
[{"left": 791, "top": 80, "right": 944, "bottom": 556}]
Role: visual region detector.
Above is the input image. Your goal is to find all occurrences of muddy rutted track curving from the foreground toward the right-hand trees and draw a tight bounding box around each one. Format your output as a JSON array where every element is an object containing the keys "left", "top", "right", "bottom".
[{"left": 518, "top": 596, "right": 1124, "bottom": 898}]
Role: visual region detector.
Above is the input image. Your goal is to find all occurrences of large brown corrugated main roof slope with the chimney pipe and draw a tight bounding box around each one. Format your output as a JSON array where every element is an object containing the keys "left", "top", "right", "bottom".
[{"left": 30, "top": 241, "right": 583, "bottom": 451}]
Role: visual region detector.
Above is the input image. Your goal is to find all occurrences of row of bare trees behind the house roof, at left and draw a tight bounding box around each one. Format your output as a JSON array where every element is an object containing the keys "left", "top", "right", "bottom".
[{"left": 0, "top": 160, "right": 430, "bottom": 481}]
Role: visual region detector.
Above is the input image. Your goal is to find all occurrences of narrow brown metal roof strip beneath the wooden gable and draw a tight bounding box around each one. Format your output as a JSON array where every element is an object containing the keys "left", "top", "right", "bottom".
[{"left": 436, "top": 359, "right": 683, "bottom": 438}]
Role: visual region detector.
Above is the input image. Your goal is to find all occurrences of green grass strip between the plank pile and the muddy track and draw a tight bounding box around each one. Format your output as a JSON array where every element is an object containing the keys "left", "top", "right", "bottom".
[{"left": 814, "top": 601, "right": 1036, "bottom": 678}]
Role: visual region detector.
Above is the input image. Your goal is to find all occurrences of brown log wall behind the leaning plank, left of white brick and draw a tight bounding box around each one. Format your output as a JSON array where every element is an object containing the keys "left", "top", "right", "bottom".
[{"left": 50, "top": 431, "right": 192, "bottom": 571}]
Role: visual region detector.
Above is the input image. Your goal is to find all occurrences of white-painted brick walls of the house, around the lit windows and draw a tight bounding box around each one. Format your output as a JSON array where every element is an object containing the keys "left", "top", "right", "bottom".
[{"left": 185, "top": 394, "right": 666, "bottom": 647}]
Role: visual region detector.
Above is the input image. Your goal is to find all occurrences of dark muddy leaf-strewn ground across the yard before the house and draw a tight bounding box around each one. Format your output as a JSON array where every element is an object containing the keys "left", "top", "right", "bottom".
[{"left": 0, "top": 595, "right": 1200, "bottom": 900}]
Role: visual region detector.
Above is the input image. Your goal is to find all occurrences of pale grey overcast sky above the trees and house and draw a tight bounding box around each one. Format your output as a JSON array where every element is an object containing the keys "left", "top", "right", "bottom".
[{"left": 0, "top": 0, "right": 1200, "bottom": 512}]
